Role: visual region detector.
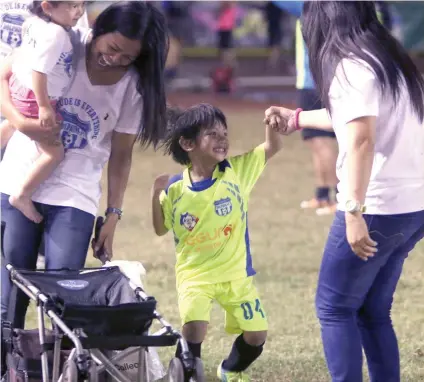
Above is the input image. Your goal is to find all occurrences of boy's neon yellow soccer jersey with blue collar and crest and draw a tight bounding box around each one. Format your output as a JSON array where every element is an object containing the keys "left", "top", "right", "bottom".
[{"left": 160, "top": 145, "right": 265, "bottom": 286}]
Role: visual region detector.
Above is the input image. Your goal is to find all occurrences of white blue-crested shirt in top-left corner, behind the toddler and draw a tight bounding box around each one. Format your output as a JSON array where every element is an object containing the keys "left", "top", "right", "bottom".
[{"left": 0, "top": 0, "right": 32, "bottom": 62}]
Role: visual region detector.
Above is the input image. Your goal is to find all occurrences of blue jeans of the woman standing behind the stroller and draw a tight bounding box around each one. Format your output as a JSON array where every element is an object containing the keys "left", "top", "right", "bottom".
[{"left": 1, "top": 194, "right": 94, "bottom": 328}]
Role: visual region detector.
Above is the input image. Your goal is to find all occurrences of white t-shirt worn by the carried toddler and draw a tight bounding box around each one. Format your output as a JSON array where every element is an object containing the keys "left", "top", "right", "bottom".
[{"left": 12, "top": 16, "right": 73, "bottom": 98}]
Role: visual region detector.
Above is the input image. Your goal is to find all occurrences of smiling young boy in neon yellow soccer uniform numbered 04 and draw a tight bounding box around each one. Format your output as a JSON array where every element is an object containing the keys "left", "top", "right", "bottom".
[{"left": 152, "top": 104, "right": 282, "bottom": 382}]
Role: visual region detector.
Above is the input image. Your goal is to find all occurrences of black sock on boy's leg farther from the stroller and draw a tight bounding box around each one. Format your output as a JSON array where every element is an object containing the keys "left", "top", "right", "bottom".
[{"left": 222, "top": 334, "right": 264, "bottom": 372}]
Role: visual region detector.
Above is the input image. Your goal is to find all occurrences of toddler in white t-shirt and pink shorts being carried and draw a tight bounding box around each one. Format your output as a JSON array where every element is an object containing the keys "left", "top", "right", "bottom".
[{"left": 0, "top": 1, "right": 85, "bottom": 223}]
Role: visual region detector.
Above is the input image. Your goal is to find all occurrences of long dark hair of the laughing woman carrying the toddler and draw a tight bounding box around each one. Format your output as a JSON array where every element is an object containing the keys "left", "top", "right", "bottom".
[{"left": 93, "top": 1, "right": 169, "bottom": 147}]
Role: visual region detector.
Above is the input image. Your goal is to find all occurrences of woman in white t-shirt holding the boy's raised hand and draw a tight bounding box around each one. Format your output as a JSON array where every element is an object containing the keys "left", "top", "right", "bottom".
[{"left": 265, "top": 1, "right": 424, "bottom": 382}]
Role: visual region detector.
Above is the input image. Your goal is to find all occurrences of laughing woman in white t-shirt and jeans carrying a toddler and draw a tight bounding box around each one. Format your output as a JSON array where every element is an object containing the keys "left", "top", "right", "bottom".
[{"left": 0, "top": 1, "right": 168, "bottom": 326}]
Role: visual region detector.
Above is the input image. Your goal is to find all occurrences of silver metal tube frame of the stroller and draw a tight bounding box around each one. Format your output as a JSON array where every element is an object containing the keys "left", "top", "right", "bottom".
[{"left": 2, "top": 264, "right": 192, "bottom": 382}]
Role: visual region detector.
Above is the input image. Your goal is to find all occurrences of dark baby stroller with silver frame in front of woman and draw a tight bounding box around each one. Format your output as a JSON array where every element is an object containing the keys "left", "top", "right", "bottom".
[{"left": 2, "top": 218, "right": 205, "bottom": 382}]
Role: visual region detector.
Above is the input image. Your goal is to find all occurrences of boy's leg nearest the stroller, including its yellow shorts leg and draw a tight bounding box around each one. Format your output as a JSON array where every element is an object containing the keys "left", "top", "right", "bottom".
[{"left": 175, "top": 285, "right": 215, "bottom": 358}]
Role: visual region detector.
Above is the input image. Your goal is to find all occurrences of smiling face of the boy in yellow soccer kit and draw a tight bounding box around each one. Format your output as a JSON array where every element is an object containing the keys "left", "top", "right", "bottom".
[{"left": 192, "top": 124, "right": 229, "bottom": 163}]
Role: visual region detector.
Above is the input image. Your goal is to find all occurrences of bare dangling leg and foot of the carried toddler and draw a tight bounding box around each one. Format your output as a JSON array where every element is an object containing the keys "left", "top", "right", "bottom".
[{"left": 9, "top": 144, "right": 65, "bottom": 223}]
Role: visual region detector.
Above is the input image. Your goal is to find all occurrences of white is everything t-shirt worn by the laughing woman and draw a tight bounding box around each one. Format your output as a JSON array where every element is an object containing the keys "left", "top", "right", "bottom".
[{"left": 0, "top": 29, "right": 143, "bottom": 215}]
